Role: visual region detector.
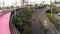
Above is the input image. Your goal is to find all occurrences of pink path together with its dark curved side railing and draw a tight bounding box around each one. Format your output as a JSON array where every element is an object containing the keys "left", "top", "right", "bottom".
[{"left": 0, "top": 10, "right": 20, "bottom": 34}]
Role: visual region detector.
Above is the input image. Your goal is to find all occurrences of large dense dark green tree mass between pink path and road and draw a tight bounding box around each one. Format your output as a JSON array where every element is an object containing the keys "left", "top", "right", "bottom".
[{"left": 12, "top": 9, "right": 34, "bottom": 34}]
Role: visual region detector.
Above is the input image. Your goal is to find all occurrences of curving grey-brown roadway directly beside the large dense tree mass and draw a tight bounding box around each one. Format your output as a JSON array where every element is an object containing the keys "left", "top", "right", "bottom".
[{"left": 32, "top": 8, "right": 47, "bottom": 34}]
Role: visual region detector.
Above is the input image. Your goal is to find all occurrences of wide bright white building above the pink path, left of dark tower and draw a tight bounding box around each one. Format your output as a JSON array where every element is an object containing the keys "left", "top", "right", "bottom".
[{"left": 0, "top": 0, "right": 21, "bottom": 7}]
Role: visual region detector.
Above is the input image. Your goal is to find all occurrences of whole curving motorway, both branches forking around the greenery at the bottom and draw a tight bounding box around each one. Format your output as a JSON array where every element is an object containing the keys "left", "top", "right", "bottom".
[{"left": 31, "top": 8, "right": 60, "bottom": 34}]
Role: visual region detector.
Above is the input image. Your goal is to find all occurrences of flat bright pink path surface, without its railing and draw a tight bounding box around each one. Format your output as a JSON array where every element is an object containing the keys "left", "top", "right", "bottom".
[{"left": 0, "top": 12, "right": 11, "bottom": 34}]
